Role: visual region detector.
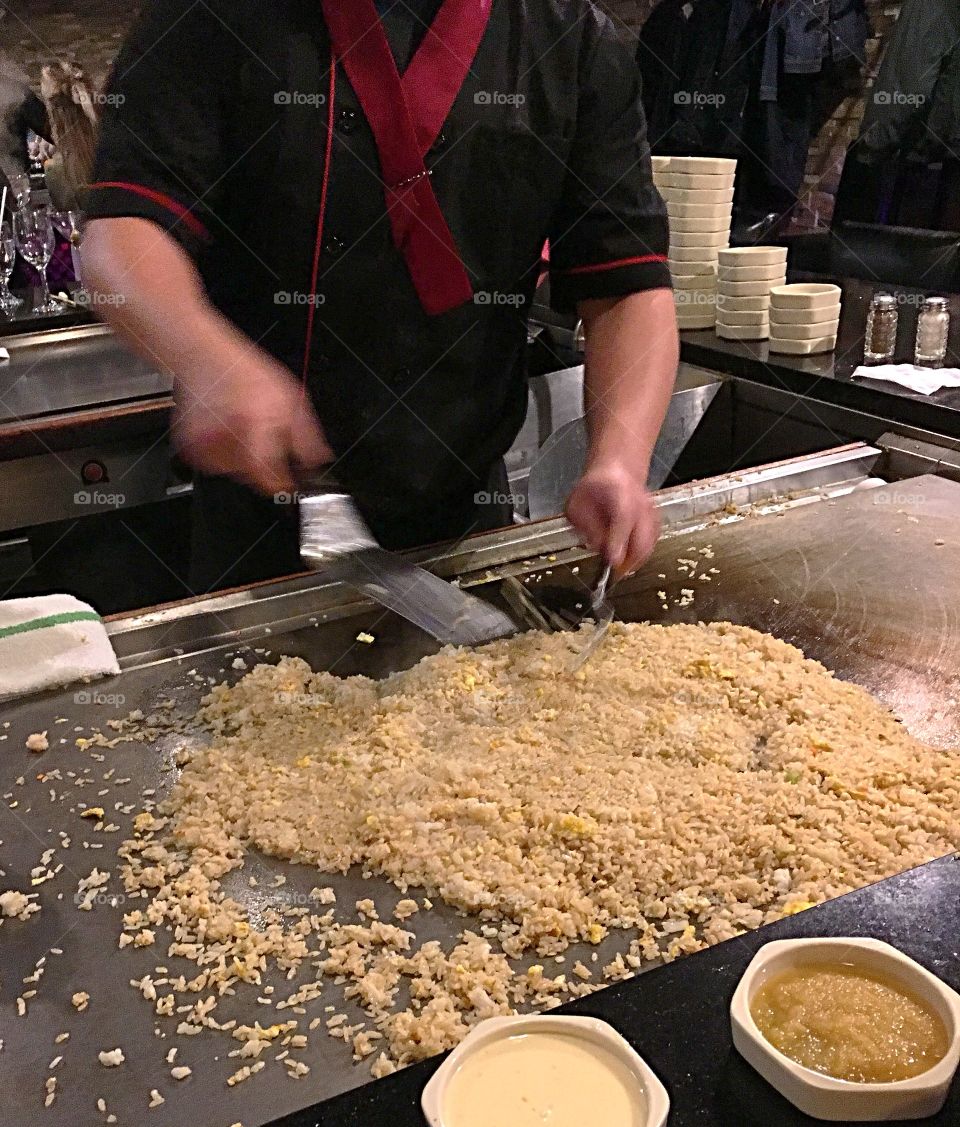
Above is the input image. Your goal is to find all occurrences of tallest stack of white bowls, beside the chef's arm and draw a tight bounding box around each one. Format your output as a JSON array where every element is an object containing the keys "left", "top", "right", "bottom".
[{"left": 654, "top": 157, "right": 737, "bottom": 329}]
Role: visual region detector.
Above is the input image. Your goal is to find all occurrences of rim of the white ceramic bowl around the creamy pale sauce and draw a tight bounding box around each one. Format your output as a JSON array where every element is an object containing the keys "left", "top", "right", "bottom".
[{"left": 420, "top": 1014, "right": 670, "bottom": 1127}]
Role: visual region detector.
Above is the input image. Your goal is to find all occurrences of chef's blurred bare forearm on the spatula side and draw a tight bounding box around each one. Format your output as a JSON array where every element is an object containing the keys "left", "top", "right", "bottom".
[{"left": 81, "top": 219, "right": 250, "bottom": 388}]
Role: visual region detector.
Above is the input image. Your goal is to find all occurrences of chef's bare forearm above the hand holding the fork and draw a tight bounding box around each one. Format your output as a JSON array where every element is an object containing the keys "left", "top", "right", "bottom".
[{"left": 579, "top": 290, "right": 679, "bottom": 485}]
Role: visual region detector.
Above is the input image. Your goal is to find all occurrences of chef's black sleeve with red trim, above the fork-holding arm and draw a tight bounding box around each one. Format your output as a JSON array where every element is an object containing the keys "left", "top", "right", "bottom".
[{"left": 550, "top": 17, "right": 670, "bottom": 311}]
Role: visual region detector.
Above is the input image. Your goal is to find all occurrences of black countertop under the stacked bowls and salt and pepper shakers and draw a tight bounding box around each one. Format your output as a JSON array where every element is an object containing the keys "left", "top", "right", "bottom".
[{"left": 681, "top": 275, "right": 960, "bottom": 438}]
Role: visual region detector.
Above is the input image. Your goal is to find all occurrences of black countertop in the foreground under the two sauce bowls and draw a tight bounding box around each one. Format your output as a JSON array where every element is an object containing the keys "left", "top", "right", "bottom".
[{"left": 273, "top": 857, "right": 960, "bottom": 1127}]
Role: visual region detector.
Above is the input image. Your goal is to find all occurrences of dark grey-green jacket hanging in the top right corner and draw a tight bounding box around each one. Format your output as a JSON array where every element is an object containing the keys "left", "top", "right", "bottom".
[{"left": 856, "top": 0, "right": 960, "bottom": 161}]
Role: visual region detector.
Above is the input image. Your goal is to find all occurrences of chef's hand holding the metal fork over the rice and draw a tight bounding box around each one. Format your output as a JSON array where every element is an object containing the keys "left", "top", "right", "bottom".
[{"left": 567, "top": 463, "right": 660, "bottom": 577}]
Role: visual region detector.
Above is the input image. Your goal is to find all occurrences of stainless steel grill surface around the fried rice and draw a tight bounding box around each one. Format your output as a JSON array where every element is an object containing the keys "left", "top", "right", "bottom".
[{"left": 0, "top": 446, "right": 960, "bottom": 1127}]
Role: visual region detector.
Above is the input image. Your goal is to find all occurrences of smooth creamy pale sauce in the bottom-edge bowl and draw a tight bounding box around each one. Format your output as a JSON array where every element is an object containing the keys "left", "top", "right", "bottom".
[{"left": 443, "top": 1033, "right": 647, "bottom": 1127}]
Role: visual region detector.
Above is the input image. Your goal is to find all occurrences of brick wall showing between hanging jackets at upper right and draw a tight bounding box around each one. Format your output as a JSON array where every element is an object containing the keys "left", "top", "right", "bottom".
[{"left": 598, "top": 0, "right": 900, "bottom": 228}]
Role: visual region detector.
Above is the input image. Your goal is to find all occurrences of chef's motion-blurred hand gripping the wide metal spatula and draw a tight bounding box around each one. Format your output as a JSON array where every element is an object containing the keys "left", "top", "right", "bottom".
[{"left": 174, "top": 341, "right": 334, "bottom": 496}]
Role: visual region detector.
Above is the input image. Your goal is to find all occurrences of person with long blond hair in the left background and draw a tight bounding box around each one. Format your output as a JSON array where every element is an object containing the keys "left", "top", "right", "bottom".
[{"left": 41, "top": 61, "right": 99, "bottom": 211}]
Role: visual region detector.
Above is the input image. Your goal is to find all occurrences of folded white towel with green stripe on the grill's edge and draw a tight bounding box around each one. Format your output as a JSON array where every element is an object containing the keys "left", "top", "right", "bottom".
[{"left": 0, "top": 595, "right": 119, "bottom": 701}]
